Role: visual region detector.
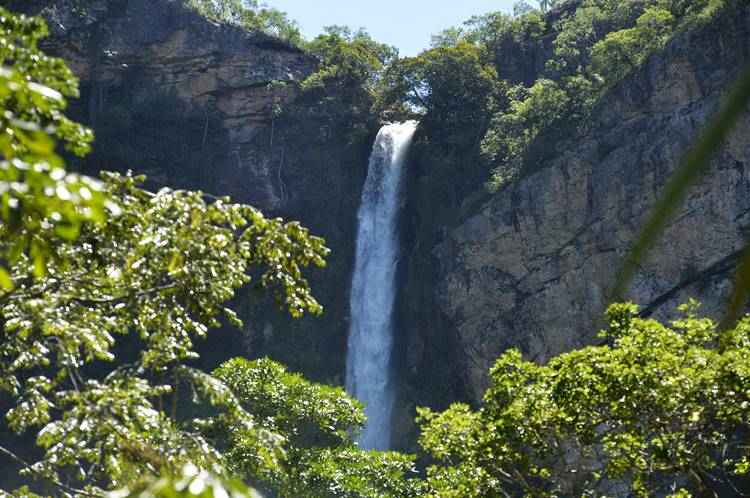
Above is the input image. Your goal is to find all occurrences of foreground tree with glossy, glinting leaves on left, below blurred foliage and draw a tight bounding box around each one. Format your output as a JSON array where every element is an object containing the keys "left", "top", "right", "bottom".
[{"left": 0, "top": 170, "right": 326, "bottom": 489}]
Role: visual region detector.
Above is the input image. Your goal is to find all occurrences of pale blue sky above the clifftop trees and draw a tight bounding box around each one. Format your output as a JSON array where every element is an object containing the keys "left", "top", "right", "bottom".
[{"left": 265, "top": 0, "right": 531, "bottom": 56}]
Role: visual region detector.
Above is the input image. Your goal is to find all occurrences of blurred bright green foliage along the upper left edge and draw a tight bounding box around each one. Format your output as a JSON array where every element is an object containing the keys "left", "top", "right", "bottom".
[{"left": 0, "top": 8, "right": 108, "bottom": 284}]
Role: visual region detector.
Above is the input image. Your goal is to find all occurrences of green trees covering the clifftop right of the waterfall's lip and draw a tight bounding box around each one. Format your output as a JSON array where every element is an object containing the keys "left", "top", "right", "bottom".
[{"left": 381, "top": 0, "right": 732, "bottom": 191}]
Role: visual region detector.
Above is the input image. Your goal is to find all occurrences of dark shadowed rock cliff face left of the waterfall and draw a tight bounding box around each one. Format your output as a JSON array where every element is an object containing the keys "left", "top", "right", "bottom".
[{"left": 25, "top": 0, "right": 376, "bottom": 381}]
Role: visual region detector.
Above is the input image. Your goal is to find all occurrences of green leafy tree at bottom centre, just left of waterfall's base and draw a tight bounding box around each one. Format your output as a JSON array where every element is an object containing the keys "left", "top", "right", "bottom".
[{"left": 215, "top": 358, "right": 420, "bottom": 498}]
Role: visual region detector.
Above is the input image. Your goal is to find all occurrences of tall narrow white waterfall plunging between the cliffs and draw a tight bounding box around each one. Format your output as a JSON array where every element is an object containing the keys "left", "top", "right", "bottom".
[{"left": 346, "top": 121, "right": 417, "bottom": 450}]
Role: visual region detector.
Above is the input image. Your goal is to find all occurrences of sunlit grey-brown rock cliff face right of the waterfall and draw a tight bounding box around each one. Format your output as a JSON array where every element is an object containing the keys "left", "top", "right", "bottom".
[{"left": 405, "top": 2, "right": 750, "bottom": 400}]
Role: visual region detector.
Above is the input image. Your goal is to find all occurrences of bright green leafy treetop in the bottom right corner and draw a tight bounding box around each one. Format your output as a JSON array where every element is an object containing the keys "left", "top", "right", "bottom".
[{"left": 421, "top": 303, "right": 750, "bottom": 498}]
